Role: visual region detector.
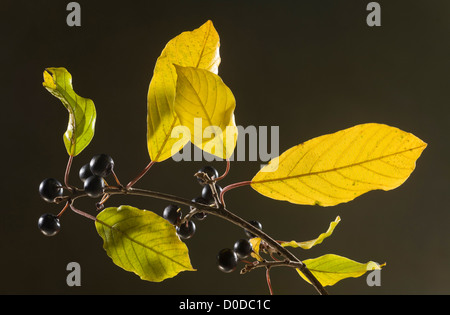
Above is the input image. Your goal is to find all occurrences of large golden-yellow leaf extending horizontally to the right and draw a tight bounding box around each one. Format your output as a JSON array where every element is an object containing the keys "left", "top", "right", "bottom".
[{"left": 251, "top": 123, "right": 427, "bottom": 206}]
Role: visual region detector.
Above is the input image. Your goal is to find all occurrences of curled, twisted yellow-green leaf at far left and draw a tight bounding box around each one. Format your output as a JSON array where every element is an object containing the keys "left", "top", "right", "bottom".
[{"left": 42, "top": 68, "right": 97, "bottom": 156}]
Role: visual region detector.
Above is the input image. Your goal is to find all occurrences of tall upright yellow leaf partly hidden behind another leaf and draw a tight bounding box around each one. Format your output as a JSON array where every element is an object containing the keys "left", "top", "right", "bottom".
[{"left": 147, "top": 21, "right": 220, "bottom": 162}]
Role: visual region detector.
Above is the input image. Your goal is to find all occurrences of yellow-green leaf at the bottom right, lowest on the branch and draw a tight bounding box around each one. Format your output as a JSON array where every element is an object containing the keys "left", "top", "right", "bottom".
[{"left": 297, "top": 254, "right": 385, "bottom": 287}]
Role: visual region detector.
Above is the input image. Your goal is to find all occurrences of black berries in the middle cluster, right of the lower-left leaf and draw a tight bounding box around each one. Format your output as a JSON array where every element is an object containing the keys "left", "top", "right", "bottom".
[{"left": 163, "top": 166, "right": 222, "bottom": 239}]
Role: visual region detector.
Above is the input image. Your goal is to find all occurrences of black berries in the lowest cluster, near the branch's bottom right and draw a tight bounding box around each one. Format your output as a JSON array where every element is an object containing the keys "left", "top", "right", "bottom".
[{"left": 217, "top": 220, "right": 262, "bottom": 273}]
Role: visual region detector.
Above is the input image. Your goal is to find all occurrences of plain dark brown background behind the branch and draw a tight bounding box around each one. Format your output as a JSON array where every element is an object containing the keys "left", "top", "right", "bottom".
[{"left": 0, "top": 0, "right": 450, "bottom": 294}]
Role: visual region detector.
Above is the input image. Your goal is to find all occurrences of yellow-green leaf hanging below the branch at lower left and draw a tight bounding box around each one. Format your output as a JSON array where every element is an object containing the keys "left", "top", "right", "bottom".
[{"left": 95, "top": 206, "right": 194, "bottom": 282}]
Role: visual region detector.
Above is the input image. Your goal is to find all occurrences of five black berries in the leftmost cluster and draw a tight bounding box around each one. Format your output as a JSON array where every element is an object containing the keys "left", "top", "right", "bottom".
[{"left": 38, "top": 154, "right": 114, "bottom": 236}]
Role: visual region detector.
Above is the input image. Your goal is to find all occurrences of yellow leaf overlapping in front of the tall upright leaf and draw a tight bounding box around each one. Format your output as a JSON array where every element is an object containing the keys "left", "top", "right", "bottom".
[{"left": 174, "top": 66, "right": 237, "bottom": 159}]
